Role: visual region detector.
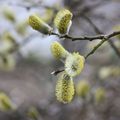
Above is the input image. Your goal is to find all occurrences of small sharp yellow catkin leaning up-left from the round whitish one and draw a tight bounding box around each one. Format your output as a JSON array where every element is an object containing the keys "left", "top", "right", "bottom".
[{"left": 51, "top": 42, "right": 69, "bottom": 59}]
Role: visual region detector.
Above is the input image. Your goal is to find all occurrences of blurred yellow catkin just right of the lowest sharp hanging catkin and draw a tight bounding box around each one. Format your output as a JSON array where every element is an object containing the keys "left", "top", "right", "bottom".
[{"left": 76, "top": 80, "right": 90, "bottom": 98}]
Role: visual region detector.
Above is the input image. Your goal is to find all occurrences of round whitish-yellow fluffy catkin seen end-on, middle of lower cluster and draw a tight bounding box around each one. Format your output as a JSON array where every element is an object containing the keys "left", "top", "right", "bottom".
[{"left": 65, "top": 53, "right": 85, "bottom": 77}]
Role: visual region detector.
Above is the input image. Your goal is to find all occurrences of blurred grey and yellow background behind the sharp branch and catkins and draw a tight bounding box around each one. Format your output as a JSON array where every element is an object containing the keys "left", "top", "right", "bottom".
[{"left": 0, "top": 0, "right": 120, "bottom": 120}]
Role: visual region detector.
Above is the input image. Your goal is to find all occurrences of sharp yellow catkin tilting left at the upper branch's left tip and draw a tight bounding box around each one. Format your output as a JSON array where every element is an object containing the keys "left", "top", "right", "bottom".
[{"left": 28, "top": 15, "right": 53, "bottom": 34}]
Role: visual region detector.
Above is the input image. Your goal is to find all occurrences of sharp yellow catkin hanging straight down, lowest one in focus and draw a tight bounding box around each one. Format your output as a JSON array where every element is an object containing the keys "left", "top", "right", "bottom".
[{"left": 56, "top": 72, "right": 74, "bottom": 103}]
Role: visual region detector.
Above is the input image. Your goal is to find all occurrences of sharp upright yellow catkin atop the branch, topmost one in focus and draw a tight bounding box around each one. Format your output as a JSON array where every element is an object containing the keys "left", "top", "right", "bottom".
[{"left": 54, "top": 9, "right": 73, "bottom": 34}]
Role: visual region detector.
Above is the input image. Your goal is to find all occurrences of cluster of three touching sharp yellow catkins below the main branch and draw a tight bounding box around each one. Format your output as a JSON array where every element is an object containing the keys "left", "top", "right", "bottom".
[{"left": 51, "top": 42, "right": 84, "bottom": 103}]
